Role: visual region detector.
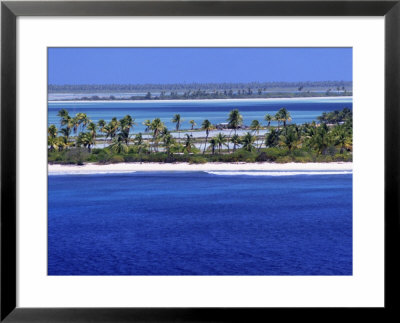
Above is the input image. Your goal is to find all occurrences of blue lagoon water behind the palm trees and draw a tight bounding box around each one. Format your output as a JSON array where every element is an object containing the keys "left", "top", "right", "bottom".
[{"left": 48, "top": 97, "right": 352, "bottom": 133}]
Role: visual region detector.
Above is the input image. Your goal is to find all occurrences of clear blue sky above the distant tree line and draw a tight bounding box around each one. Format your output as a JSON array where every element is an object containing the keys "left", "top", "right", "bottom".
[{"left": 48, "top": 47, "right": 352, "bottom": 84}]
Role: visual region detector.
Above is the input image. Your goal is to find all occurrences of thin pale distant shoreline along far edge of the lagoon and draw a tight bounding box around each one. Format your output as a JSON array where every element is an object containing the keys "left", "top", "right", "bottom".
[{"left": 47, "top": 96, "right": 353, "bottom": 103}]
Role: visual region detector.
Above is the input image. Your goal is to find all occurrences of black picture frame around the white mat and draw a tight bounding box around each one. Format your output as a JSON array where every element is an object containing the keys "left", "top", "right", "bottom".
[{"left": 0, "top": 0, "right": 400, "bottom": 322}]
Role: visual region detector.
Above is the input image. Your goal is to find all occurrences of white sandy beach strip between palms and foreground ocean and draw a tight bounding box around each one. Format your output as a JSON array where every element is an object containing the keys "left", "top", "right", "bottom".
[{"left": 48, "top": 162, "right": 353, "bottom": 174}]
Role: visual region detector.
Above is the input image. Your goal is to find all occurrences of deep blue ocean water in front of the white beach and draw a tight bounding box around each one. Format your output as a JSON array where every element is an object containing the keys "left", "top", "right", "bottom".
[{"left": 48, "top": 172, "right": 352, "bottom": 275}]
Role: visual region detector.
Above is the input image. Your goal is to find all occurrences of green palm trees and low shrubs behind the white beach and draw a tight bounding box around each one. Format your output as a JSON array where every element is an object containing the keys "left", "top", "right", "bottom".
[{"left": 48, "top": 108, "right": 353, "bottom": 165}]
